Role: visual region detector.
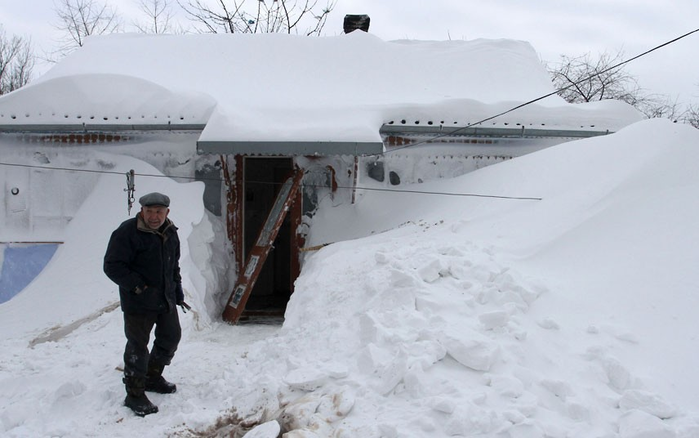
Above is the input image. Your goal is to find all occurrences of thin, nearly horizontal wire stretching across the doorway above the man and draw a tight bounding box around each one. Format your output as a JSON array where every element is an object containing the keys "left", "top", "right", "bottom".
[{"left": 0, "top": 162, "right": 542, "bottom": 201}]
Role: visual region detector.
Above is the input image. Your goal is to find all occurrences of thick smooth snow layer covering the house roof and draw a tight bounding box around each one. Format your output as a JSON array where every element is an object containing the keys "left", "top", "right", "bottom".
[{"left": 0, "top": 32, "right": 638, "bottom": 141}]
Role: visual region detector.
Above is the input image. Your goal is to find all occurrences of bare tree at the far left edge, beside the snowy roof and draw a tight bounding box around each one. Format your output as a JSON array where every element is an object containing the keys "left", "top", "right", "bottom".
[{"left": 0, "top": 26, "right": 36, "bottom": 95}]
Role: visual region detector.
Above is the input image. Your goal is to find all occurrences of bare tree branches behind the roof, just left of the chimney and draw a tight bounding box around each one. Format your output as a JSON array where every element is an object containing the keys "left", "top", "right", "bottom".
[{"left": 178, "top": 0, "right": 337, "bottom": 35}]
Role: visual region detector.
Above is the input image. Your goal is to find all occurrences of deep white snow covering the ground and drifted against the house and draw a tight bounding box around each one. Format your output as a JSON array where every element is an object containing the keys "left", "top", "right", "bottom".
[{"left": 0, "top": 120, "right": 699, "bottom": 438}]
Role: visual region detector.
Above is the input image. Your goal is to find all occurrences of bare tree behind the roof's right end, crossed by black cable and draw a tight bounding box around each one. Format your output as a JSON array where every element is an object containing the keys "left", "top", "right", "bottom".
[{"left": 547, "top": 52, "right": 645, "bottom": 106}]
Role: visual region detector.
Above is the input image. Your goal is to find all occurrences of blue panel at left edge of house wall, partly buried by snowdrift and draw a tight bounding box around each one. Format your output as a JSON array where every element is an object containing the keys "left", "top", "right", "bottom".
[{"left": 0, "top": 243, "right": 58, "bottom": 304}]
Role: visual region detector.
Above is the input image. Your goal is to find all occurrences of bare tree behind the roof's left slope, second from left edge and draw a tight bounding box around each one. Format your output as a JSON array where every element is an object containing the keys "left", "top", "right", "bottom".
[{"left": 56, "top": 0, "right": 121, "bottom": 55}]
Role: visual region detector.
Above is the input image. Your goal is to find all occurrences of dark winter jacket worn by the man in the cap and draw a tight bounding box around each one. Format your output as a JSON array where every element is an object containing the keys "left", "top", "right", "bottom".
[{"left": 104, "top": 213, "right": 184, "bottom": 313}]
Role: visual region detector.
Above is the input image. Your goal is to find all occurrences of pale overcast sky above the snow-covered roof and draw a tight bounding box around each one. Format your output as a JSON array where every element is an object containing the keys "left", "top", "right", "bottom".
[{"left": 0, "top": 0, "right": 699, "bottom": 103}]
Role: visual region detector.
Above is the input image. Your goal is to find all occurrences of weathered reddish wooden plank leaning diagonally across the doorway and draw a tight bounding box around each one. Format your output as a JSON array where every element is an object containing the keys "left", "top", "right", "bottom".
[{"left": 223, "top": 169, "right": 303, "bottom": 324}]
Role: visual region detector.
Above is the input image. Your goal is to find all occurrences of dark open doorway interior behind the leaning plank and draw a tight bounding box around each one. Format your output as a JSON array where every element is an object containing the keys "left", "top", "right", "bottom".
[{"left": 243, "top": 157, "right": 293, "bottom": 316}]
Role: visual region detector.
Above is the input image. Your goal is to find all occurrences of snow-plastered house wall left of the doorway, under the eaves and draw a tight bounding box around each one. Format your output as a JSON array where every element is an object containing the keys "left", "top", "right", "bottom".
[{"left": 0, "top": 133, "right": 202, "bottom": 241}]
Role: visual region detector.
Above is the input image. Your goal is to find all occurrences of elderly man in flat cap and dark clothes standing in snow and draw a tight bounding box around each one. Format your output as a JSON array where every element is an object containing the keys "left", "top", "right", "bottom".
[{"left": 104, "top": 192, "right": 186, "bottom": 416}]
